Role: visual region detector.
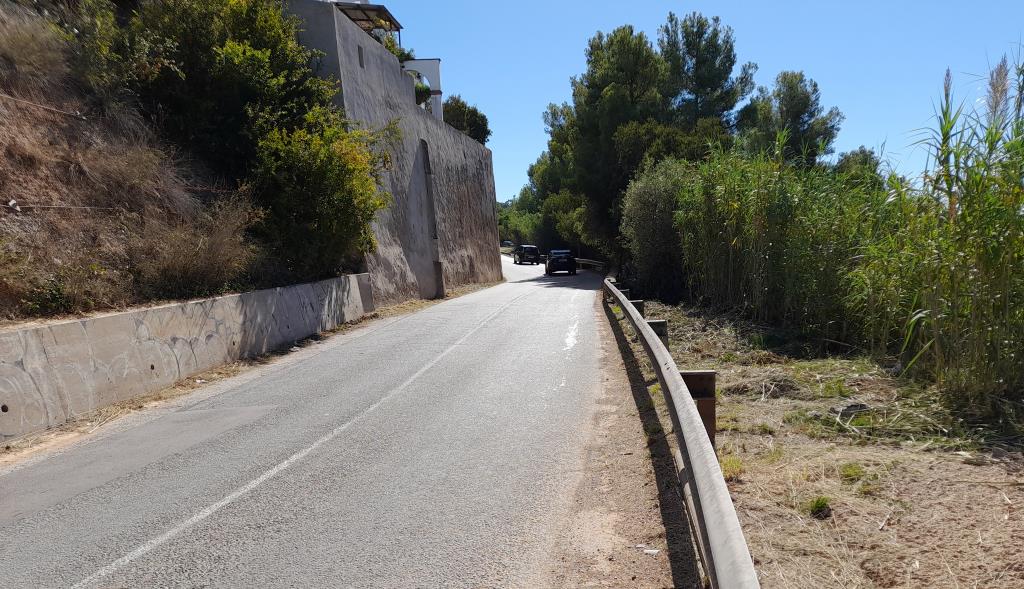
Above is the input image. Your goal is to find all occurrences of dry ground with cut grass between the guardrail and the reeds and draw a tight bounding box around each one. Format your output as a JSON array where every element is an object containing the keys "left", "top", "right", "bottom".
[{"left": 622, "top": 301, "right": 1024, "bottom": 589}]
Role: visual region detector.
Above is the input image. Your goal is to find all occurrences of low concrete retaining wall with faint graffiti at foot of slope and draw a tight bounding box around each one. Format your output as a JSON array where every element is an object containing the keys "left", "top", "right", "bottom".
[{"left": 0, "top": 274, "right": 374, "bottom": 440}]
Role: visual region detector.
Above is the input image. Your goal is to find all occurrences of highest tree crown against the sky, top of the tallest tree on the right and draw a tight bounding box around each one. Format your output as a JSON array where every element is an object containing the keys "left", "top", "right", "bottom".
[{"left": 657, "top": 12, "right": 758, "bottom": 130}]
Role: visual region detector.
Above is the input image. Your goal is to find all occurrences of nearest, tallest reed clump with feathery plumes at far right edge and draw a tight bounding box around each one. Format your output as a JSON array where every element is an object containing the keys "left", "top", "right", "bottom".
[{"left": 849, "top": 58, "right": 1024, "bottom": 422}]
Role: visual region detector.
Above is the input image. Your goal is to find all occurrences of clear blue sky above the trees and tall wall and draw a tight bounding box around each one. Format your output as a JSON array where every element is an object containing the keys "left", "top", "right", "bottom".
[{"left": 379, "top": 0, "right": 1024, "bottom": 201}]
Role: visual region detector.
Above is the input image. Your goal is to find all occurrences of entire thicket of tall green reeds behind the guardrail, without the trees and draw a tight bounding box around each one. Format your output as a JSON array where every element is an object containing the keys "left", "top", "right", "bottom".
[{"left": 624, "top": 59, "right": 1024, "bottom": 427}]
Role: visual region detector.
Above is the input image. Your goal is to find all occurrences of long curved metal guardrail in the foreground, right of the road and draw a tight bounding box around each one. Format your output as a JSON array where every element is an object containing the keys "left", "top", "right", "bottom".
[{"left": 604, "top": 278, "right": 761, "bottom": 589}]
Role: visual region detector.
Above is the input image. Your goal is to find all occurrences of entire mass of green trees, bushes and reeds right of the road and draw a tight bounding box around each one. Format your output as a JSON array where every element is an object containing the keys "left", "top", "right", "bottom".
[{"left": 516, "top": 9, "right": 1024, "bottom": 436}]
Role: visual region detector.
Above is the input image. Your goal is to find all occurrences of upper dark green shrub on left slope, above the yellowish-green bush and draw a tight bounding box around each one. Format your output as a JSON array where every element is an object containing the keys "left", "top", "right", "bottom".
[{"left": 121, "top": 0, "right": 337, "bottom": 177}]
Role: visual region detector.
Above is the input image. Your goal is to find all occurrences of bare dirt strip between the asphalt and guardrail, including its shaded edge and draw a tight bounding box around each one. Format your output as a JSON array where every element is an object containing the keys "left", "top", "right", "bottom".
[{"left": 549, "top": 300, "right": 699, "bottom": 587}]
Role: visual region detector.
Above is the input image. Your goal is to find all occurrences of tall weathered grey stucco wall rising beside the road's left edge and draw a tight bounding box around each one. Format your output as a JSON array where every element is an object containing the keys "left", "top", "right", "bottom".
[{"left": 289, "top": 0, "right": 502, "bottom": 302}]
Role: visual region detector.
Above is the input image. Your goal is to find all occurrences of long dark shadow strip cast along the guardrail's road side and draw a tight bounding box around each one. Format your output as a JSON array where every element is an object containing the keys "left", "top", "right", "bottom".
[{"left": 601, "top": 304, "right": 700, "bottom": 587}]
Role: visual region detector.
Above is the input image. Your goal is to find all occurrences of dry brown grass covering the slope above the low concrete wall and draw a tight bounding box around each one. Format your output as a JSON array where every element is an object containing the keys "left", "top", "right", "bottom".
[{"left": 0, "top": 2, "right": 255, "bottom": 321}]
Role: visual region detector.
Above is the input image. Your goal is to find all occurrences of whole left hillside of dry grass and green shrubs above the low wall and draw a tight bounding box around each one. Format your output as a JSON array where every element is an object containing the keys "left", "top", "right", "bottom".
[{"left": 0, "top": 0, "right": 396, "bottom": 319}]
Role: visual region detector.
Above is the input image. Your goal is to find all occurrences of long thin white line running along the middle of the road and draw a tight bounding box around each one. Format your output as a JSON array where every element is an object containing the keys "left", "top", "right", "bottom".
[{"left": 72, "top": 292, "right": 530, "bottom": 589}]
